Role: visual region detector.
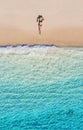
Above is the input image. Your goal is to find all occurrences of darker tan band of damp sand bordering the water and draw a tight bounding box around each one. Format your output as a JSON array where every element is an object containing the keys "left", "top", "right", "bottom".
[{"left": 0, "top": 27, "right": 83, "bottom": 47}]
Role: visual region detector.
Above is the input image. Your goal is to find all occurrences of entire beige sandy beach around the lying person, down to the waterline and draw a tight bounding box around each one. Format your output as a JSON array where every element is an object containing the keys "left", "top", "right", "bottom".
[{"left": 0, "top": 0, "right": 83, "bottom": 47}]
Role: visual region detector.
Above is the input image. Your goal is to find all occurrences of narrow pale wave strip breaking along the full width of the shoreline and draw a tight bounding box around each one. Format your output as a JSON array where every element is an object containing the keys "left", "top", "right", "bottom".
[{"left": 0, "top": 44, "right": 83, "bottom": 55}]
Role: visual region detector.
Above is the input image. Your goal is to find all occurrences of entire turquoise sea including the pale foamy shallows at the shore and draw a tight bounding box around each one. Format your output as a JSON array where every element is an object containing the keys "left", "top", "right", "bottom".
[{"left": 0, "top": 46, "right": 83, "bottom": 130}]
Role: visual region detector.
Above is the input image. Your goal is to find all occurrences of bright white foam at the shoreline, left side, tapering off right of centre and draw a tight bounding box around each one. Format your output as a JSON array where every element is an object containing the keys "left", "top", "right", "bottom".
[{"left": 0, "top": 45, "right": 55, "bottom": 54}]
